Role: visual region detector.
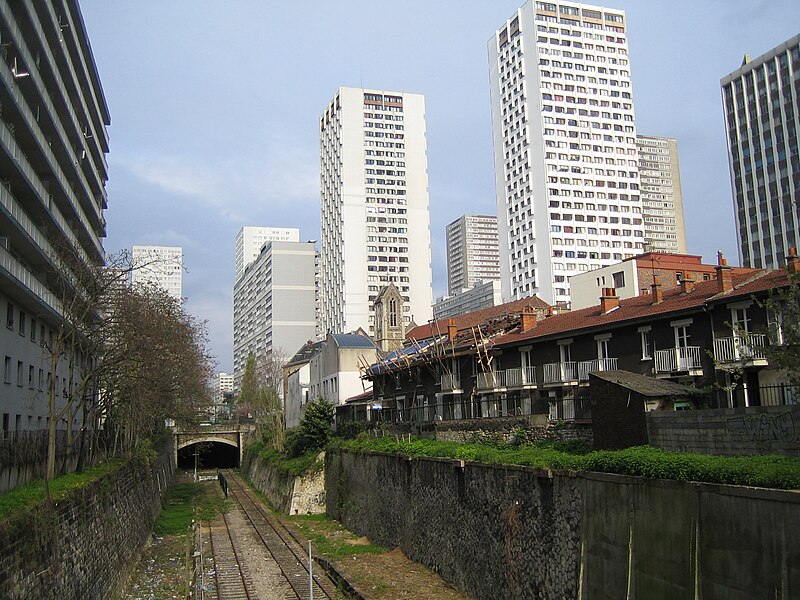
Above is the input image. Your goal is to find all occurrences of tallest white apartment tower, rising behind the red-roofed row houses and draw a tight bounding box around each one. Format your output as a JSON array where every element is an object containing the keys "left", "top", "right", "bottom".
[{"left": 488, "top": 0, "right": 644, "bottom": 304}]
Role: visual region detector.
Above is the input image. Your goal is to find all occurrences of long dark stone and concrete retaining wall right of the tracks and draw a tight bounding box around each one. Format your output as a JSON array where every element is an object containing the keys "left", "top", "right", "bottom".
[{"left": 325, "top": 452, "right": 800, "bottom": 600}]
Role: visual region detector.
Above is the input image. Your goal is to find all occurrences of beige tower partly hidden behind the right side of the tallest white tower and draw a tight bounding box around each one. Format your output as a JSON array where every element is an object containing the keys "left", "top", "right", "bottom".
[{"left": 636, "top": 135, "right": 687, "bottom": 254}]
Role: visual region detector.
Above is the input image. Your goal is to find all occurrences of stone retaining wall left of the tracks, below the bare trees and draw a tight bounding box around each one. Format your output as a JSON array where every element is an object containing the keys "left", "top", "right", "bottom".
[{"left": 0, "top": 438, "right": 175, "bottom": 600}]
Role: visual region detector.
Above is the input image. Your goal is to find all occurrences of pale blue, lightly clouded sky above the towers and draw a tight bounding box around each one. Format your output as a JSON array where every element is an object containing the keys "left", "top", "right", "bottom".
[{"left": 80, "top": 0, "right": 800, "bottom": 371}]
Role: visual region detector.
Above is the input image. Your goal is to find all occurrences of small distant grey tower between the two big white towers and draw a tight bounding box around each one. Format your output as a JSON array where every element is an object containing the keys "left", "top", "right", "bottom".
[{"left": 445, "top": 215, "right": 500, "bottom": 296}]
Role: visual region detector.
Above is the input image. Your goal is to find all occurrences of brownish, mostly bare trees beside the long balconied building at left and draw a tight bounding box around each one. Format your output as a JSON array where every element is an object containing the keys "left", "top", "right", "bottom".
[{"left": 42, "top": 239, "right": 213, "bottom": 495}]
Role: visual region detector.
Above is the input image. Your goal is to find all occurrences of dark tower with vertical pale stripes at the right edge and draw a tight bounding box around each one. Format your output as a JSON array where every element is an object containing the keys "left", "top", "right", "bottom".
[{"left": 721, "top": 35, "right": 800, "bottom": 268}]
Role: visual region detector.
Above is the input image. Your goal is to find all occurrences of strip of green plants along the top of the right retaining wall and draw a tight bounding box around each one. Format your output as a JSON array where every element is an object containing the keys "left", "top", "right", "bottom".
[{"left": 335, "top": 436, "right": 800, "bottom": 489}]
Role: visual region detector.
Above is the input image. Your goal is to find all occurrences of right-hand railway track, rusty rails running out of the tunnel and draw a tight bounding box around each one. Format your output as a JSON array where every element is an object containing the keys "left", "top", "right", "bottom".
[{"left": 220, "top": 473, "right": 337, "bottom": 600}]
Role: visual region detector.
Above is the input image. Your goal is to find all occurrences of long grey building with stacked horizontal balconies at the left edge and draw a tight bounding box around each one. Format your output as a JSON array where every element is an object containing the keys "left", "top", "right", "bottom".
[{"left": 0, "top": 0, "right": 111, "bottom": 439}]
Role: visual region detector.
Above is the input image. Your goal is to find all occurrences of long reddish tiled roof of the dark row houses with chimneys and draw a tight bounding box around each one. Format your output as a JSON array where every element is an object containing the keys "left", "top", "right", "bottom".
[{"left": 494, "top": 270, "right": 787, "bottom": 345}]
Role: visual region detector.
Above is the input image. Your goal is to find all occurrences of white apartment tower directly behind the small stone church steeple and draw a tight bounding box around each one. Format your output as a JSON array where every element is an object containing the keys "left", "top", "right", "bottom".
[{"left": 320, "top": 87, "right": 432, "bottom": 335}]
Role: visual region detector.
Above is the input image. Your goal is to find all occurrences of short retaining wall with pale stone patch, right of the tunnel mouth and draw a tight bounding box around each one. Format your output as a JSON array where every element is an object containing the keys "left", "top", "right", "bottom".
[{"left": 242, "top": 452, "right": 325, "bottom": 515}]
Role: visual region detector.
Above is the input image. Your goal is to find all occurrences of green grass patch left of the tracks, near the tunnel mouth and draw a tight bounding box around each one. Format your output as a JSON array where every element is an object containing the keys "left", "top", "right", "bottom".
[{"left": 153, "top": 483, "right": 229, "bottom": 536}]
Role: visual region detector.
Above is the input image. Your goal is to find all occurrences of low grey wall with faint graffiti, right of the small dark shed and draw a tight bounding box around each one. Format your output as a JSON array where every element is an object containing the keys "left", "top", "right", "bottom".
[{"left": 645, "top": 405, "right": 800, "bottom": 456}]
